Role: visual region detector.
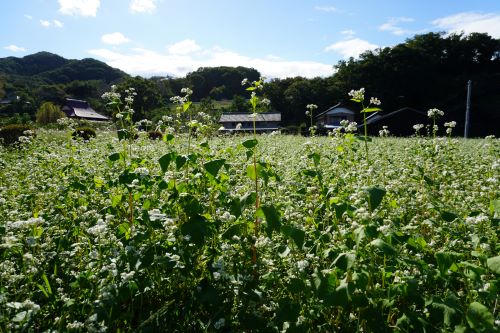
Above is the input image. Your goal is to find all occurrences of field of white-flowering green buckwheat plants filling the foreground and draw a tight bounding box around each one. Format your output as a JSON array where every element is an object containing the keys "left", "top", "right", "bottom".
[{"left": 0, "top": 124, "right": 500, "bottom": 332}]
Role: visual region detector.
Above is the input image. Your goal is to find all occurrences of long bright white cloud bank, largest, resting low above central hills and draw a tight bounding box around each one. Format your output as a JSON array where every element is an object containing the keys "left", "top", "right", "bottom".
[{"left": 88, "top": 41, "right": 334, "bottom": 78}]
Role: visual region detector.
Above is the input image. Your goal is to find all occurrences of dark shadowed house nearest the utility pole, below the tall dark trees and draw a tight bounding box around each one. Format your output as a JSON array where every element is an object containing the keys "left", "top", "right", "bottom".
[{"left": 360, "top": 107, "right": 430, "bottom": 136}]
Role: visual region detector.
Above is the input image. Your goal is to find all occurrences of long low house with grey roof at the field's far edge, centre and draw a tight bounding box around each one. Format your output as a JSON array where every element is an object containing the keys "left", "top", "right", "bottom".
[{"left": 219, "top": 112, "right": 281, "bottom": 132}]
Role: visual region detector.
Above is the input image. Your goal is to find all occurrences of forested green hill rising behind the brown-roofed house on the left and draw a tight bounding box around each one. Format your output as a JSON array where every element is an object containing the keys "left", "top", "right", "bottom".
[{"left": 0, "top": 52, "right": 128, "bottom": 110}]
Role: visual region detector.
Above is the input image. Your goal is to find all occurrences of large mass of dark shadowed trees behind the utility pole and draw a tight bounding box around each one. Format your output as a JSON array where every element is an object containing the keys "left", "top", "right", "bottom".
[{"left": 333, "top": 33, "right": 500, "bottom": 136}]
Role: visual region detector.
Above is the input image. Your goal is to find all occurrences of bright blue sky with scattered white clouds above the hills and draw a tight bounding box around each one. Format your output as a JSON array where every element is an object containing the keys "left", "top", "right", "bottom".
[{"left": 0, "top": 0, "right": 500, "bottom": 78}]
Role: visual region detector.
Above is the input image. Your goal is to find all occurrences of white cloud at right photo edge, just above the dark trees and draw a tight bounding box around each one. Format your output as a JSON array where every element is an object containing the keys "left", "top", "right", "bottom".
[{"left": 432, "top": 12, "right": 500, "bottom": 38}]
